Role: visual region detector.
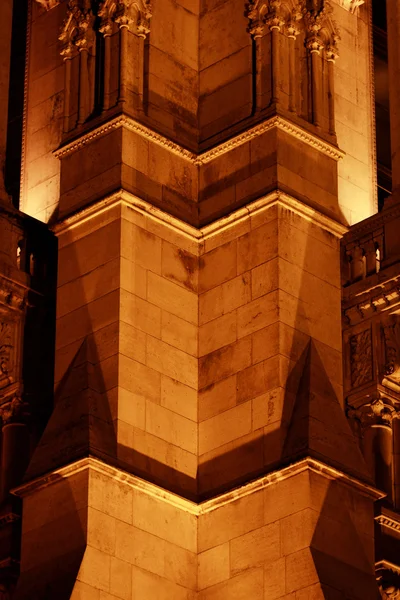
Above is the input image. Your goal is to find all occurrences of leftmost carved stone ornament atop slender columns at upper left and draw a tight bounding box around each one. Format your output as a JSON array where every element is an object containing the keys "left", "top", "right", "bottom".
[{"left": 58, "top": 0, "right": 95, "bottom": 58}]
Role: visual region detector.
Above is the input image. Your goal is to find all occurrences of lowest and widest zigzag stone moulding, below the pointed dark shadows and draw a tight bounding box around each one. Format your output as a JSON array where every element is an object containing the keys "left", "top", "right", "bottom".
[{"left": 12, "top": 456, "right": 386, "bottom": 517}]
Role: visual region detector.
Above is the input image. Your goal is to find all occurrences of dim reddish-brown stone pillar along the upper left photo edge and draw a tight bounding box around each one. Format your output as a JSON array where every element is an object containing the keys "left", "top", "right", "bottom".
[{"left": 0, "top": 0, "right": 13, "bottom": 203}]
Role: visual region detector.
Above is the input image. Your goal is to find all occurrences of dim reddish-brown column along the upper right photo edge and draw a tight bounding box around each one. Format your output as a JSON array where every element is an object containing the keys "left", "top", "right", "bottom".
[{"left": 386, "top": 0, "right": 400, "bottom": 195}]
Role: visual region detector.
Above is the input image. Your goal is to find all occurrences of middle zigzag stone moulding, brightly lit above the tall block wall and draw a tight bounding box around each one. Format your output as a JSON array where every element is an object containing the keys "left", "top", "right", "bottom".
[{"left": 53, "top": 190, "right": 348, "bottom": 244}]
